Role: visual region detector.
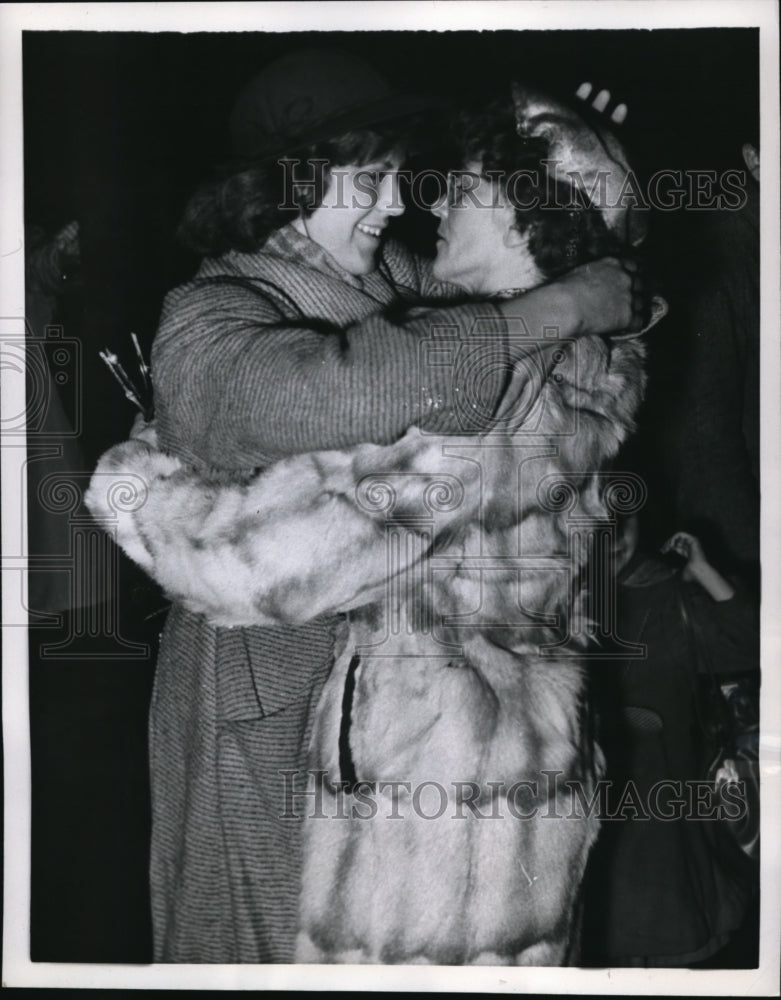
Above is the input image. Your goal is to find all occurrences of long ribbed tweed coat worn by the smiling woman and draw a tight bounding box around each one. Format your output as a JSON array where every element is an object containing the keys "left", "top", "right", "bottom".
[{"left": 136, "top": 227, "right": 504, "bottom": 962}]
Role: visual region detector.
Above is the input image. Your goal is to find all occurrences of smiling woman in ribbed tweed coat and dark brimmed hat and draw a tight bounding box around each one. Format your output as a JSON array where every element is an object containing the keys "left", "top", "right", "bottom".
[{"left": 137, "top": 52, "right": 631, "bottom": 962}]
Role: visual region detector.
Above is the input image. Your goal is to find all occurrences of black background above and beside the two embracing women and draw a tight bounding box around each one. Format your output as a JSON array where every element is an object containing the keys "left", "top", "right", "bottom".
[{"left": 23, "top": 29, "right": 758, "bottom": 962}]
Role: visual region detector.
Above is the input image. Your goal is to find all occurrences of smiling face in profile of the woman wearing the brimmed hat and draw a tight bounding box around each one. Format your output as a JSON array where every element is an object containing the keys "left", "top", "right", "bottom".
[{"left": 294, "top": 153, "right": 404, "bottom": 276}]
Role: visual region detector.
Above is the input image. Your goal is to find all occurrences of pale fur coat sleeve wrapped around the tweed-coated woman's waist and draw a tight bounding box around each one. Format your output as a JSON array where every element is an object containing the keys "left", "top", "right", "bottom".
[{"left": 87, "top": 420, "right": 464, "bottom": 626}]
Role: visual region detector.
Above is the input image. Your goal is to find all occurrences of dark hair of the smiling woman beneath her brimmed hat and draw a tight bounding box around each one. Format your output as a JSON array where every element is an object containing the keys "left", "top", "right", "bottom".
[{"left": 177, "top": 118, "right": 421, "bottom": 256}]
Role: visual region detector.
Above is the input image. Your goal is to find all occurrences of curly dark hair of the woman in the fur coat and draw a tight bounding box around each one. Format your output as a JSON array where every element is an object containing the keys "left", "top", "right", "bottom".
[{"left": 453, "top": 96, "right": 619, "bottom": 278}]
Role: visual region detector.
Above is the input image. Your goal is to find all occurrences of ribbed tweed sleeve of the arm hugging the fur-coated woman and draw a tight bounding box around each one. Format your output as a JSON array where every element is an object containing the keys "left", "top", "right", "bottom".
[{"left": 152, "top": 281, "right": 509, "bottom": 469}]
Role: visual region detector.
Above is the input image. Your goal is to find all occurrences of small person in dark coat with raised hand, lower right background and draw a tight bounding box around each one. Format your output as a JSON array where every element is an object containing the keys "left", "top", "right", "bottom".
[{"left": 584, "top": 517, "right": 758, "bottom": 966}]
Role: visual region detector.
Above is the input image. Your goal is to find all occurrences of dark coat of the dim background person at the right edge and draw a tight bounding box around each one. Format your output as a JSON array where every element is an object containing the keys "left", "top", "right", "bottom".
[{"left": 674, "top": 144, "right": 759, "bottom": 577}]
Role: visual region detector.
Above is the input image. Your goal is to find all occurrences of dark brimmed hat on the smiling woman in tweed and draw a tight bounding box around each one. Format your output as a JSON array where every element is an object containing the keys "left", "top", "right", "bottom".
[{"left": 230, "top": 49, "right": 444, "bottom": 160}]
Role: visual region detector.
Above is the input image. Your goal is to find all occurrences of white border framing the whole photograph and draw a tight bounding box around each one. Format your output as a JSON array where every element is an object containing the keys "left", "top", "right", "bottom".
[{"left": 0, "top": 0, "right": 781, "bottom": 996}]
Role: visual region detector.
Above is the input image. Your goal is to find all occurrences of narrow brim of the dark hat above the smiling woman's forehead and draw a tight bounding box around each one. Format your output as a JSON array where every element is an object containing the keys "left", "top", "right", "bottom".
[{"left": 240, "top": 94, "right": 449, "bottom": 163}]
